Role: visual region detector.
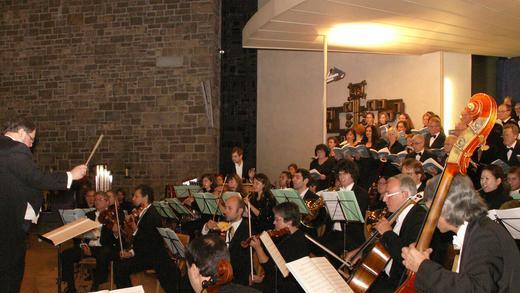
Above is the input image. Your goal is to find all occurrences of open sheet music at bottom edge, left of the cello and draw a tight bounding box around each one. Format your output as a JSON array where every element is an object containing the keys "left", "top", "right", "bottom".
[{"left": 287, "top": 256, "right": 354, "bottom": 293}]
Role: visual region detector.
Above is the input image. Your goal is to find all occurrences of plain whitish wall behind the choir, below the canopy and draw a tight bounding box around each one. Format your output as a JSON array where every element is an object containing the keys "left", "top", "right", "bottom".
[{"left": 257, "top": 50, "right": 471, "bottom": 181}]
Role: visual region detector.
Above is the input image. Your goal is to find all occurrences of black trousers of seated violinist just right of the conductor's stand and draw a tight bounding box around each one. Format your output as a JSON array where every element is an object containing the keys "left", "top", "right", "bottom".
[{"left": 61, "top": 246, "right": 115, "bottom": 286}]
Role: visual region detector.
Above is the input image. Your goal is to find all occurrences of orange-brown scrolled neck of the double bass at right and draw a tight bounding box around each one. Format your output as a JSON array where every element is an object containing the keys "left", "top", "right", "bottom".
[{"left": 395, "top": 93, "right": 497, "bottom": 293}]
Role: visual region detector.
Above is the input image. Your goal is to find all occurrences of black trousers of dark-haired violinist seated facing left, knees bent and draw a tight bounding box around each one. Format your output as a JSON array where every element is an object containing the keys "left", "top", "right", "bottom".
[{"left": 114, "top": 254, "right": 180, "bottom": 293}]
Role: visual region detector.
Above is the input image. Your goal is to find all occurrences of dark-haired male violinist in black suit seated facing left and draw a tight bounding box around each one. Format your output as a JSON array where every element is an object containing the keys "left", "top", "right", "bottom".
[{"left": 114, "top": 185, "right": 179, "bottom": 293}]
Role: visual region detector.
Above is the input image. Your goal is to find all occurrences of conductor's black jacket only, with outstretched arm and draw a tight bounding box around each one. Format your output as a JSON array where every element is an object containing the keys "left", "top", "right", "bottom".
[{"left": 0, "top": 135, "right": 67, "bottom": 233}]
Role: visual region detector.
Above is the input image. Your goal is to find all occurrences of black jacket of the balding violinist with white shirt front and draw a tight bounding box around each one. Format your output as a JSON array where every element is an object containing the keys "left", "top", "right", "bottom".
[{"left": 228, "top": 218, "right": 251, "bottom": 286}]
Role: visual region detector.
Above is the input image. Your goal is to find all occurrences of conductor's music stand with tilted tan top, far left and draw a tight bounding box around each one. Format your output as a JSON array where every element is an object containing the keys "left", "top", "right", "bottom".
[{"left": 38, "top": 217, "right": 99, "bottom": 293}]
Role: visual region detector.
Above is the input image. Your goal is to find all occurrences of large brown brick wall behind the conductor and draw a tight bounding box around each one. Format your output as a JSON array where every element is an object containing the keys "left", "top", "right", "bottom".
[{"left": 0, "top": 0, "right": 220, "bottom": 196}]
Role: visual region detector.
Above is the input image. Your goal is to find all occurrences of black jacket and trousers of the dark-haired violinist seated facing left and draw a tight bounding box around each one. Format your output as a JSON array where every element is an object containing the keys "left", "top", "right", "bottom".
[{"left": 114, "top": 205, "right": 179, "bottom": 293}]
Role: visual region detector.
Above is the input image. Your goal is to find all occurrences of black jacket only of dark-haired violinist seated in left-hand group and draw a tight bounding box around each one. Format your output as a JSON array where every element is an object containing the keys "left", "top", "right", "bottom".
[{"left": 133, "top": 205, "right": 168, "bottom": 260}]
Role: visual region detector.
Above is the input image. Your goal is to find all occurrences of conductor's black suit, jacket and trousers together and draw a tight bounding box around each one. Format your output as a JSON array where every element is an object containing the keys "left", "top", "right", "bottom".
[{"left": 0, "top": 135, "right": 67, "bottom": 292}]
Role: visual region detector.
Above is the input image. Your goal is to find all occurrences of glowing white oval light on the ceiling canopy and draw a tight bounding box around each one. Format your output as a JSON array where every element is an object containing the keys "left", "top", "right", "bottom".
[{"left": 327, "top": 23, "right": 397, "bottom": 47}]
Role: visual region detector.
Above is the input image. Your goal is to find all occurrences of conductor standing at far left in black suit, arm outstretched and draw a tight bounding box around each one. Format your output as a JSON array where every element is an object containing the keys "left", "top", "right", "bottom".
[{"left": 0, "top": 116, "right": 87, "bottom": 293}]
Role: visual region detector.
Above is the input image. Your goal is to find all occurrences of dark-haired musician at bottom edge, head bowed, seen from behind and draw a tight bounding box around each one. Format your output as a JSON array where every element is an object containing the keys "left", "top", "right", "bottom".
[{"left": 186, "top": 235, "right": 258, "bottom": 293}]
